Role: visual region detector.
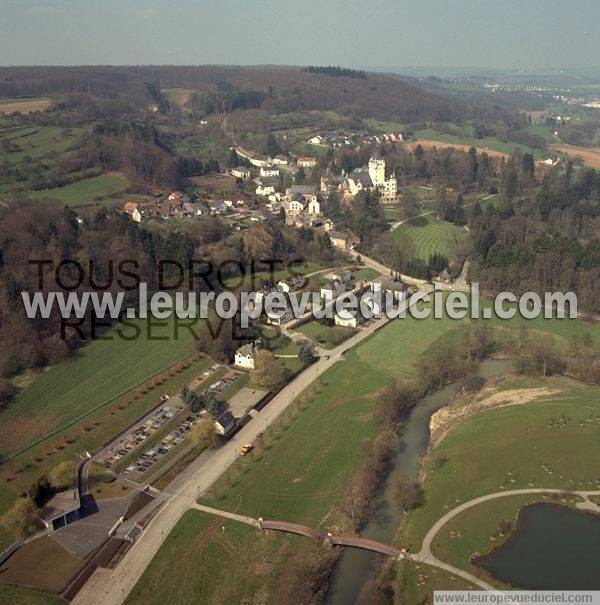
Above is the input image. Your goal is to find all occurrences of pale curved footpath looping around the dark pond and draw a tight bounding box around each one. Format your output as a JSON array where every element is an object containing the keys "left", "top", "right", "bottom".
[{"left": 410, "top": 488, "right": 600, "bottom": 590}]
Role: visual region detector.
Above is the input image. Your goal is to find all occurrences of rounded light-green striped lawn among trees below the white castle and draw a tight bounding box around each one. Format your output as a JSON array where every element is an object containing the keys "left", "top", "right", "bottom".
[{"left": 391, "top": 215, "right": 468, "bottom": 262}]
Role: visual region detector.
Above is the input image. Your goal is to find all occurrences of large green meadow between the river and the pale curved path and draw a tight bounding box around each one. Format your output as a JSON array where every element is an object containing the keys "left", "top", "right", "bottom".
[{"left": 398, "top": 377, "right": 600, "bottom": 559}]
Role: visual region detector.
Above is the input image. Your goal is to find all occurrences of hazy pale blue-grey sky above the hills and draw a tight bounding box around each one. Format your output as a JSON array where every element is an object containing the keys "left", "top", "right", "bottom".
[{"left": 0, "top": 0, "right": 600, "bottom": 69}]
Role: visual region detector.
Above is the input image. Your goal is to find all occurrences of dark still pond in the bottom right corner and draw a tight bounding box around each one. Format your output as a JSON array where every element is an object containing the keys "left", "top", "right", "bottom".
[{"left": 473, "top": 503, "right": 600, "bottom": 590}]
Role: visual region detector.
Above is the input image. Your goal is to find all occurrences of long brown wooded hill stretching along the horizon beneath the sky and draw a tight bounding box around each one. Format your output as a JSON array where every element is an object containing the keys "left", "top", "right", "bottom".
[{"left": 0, "top": 66, "right": 470, "bottom": 122}]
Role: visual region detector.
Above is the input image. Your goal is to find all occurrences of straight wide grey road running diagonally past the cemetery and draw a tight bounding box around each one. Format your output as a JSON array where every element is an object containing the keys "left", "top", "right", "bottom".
[{"left": 73, "top": 317, "right": 390, "bottom": 605}]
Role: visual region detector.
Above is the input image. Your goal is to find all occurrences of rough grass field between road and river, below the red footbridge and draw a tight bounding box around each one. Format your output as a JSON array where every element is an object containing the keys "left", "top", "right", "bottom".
[{"left": 127, "top": 510, "right": 316, "bottom": 605}]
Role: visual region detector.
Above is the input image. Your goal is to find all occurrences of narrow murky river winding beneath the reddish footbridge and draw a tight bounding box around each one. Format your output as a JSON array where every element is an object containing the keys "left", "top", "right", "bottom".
[{"left": 327, "top": 359, "right": 513, "bottom": 605}]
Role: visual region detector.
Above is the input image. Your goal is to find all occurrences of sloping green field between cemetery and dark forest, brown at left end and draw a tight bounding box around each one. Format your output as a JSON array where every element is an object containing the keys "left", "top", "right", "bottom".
[{"left": 0, "top": 317, "right": 202, "bottom": 456}]
